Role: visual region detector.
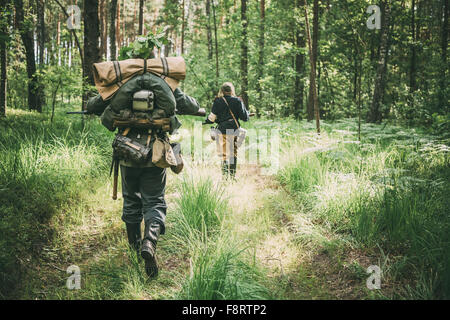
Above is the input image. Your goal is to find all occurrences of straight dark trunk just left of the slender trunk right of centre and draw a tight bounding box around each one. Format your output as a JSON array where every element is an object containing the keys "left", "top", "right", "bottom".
[{"left": 294, "top": 0, "right": 305, "bottom": 119}]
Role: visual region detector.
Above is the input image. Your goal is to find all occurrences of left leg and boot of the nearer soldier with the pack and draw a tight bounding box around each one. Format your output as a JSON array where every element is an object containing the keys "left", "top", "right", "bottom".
[{"left": 120, "top": 166, "right": 142, "bottom": 250}]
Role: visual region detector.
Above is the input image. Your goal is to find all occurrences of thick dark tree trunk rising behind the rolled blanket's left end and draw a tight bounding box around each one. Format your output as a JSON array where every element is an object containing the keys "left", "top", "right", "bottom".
[{"left": 83, "top": 0, "right": 100, "bottom": 108}]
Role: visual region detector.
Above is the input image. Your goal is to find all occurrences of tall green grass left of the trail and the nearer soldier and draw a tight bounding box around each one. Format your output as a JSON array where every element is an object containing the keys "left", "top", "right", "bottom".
[{"left": 0, "top": 111, "right": 109, "bottom": 298}]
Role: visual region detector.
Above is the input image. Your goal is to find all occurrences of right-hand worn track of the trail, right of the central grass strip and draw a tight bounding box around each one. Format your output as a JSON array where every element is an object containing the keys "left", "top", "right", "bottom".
[{"left": 242, "top": 166, "right": 376, "bottom": 299}]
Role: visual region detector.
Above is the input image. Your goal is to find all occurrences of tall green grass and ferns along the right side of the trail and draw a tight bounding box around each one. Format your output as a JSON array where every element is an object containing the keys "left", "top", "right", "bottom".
[{"left": 278, "top": 120, "right": 450, "bottom": 298}]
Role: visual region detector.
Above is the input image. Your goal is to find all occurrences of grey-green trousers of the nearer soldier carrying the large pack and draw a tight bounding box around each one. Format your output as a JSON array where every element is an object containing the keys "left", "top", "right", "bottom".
[{"left": 120, "top": 165, "right": 167, "bottom": 234}]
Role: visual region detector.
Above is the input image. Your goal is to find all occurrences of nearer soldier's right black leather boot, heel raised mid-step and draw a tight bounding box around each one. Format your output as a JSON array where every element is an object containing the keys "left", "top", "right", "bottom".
[{"left": 141, "top": 221, "right": 161, "bottom": 278}]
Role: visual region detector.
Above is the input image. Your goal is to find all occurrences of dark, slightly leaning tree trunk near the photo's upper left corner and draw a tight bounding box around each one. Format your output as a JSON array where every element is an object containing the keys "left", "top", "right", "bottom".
[{"left": 14, "top": 0, "right": 42, "bottom": 112}]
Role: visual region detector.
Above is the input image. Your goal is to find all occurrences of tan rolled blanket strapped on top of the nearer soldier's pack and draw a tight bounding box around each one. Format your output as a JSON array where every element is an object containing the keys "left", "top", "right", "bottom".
[{"left": 93, "top": 57, "right": 186, "bottom": 100}]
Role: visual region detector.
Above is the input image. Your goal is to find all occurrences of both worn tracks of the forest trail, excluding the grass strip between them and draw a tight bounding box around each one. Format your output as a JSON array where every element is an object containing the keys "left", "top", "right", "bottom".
[{"left": 30, "top": 165, "right": 370, "bottom": 299}]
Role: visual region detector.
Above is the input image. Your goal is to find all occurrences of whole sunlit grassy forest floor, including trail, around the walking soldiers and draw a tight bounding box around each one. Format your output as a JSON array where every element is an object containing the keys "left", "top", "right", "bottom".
[{"left": 0, "top": 111, "right": 450, "bottom": 299}]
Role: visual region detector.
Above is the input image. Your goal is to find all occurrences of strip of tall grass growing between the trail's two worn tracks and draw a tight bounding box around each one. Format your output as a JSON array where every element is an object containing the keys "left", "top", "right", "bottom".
[{"left": 173, "top": 178, "right": 268, "bottom": 300}]
